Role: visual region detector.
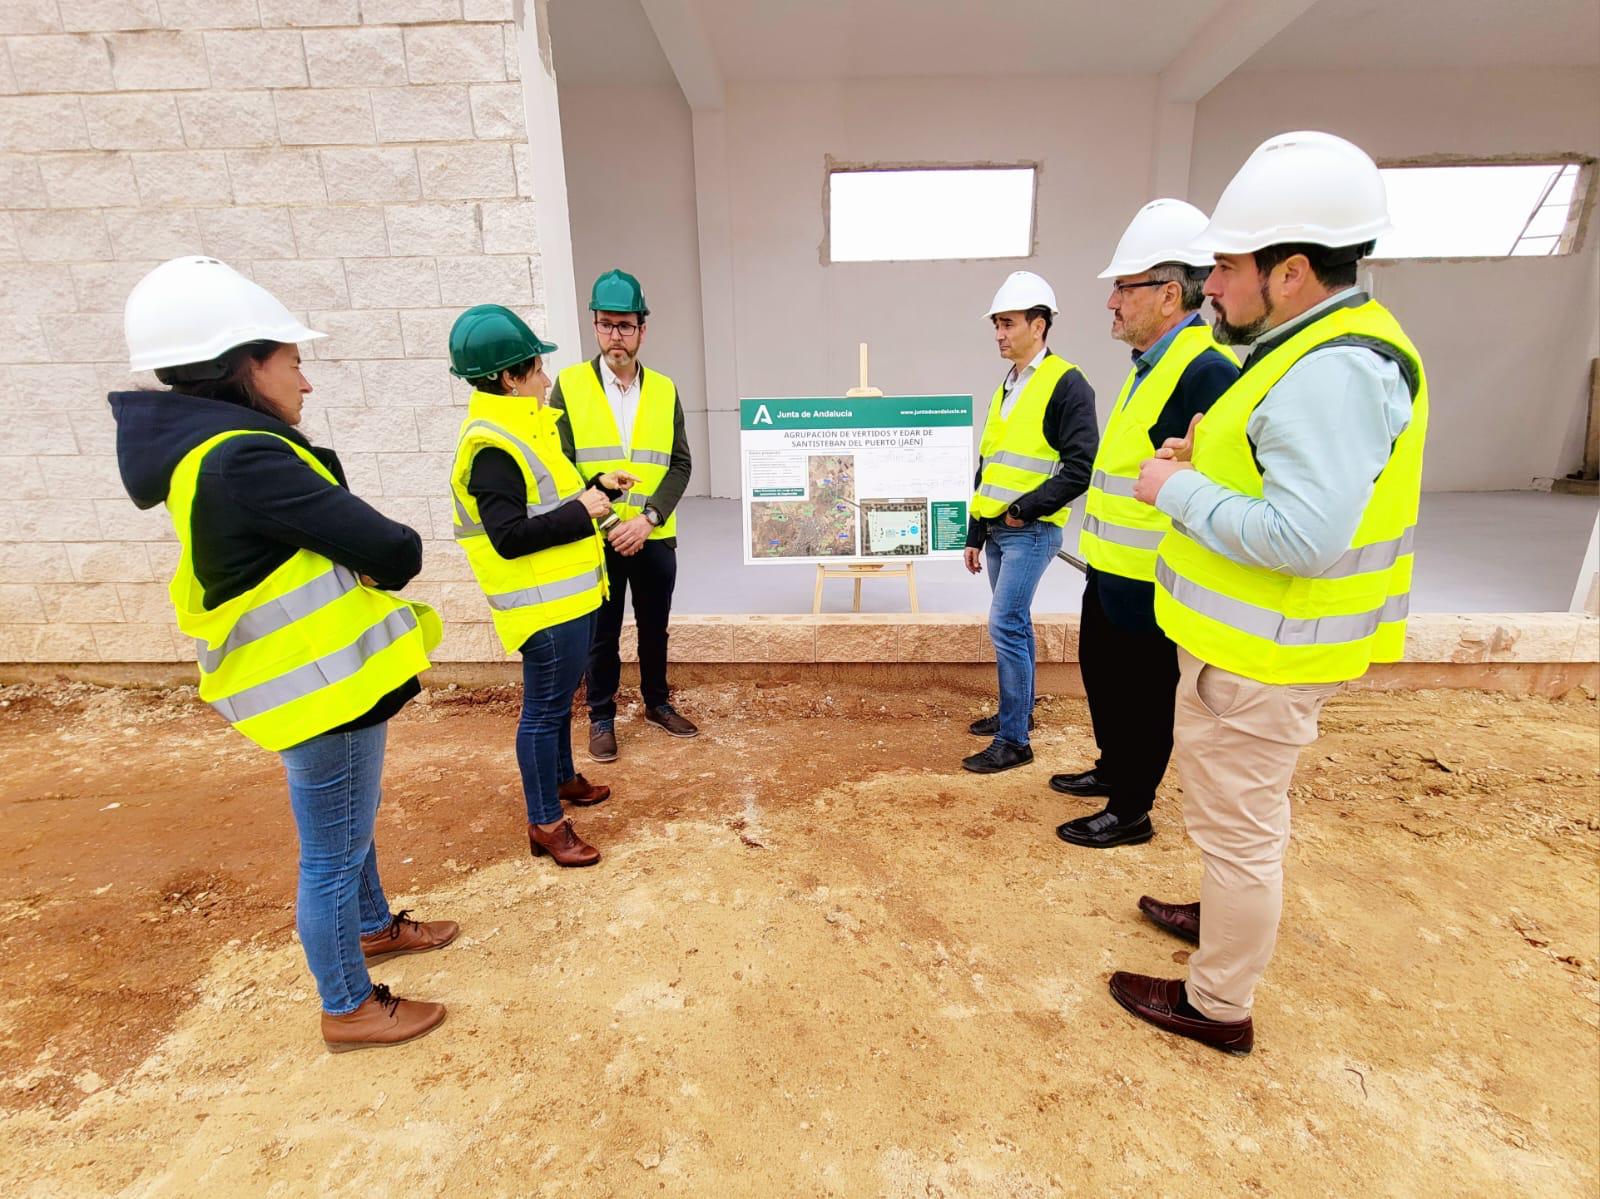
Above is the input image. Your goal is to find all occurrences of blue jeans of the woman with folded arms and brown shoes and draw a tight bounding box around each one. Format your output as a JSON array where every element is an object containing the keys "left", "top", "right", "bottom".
[{"left": 278, "top": 722, "right": 389, "bottom": 1017}]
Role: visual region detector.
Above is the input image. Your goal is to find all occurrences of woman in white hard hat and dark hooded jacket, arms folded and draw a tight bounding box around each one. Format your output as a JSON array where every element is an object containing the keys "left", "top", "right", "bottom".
[{"left": 110, "top": 256, "right": 458, "bottom": 1052}]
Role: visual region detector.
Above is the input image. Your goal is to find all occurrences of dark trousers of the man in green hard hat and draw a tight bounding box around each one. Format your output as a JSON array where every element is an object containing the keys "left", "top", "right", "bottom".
[{"left": 589, "top": 539, "right": 678, "bottom": 722}]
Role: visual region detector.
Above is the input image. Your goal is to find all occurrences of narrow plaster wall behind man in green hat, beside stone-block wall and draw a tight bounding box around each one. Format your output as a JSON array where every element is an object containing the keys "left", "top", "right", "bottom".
[{"left": 557, "top": 82, "right": 710, "bottom": 495}]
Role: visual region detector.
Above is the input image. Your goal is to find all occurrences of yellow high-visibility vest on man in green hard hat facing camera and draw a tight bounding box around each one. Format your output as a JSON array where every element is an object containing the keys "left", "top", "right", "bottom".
[{"left": 557, "top": 362, "right": 678, "bottom": 538}]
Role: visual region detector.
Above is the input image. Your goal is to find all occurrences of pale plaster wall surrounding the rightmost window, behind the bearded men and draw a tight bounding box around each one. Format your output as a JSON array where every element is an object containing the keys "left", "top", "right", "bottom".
[{"left": 1190, "top": 69, "right": 1600, "bottom": 491}]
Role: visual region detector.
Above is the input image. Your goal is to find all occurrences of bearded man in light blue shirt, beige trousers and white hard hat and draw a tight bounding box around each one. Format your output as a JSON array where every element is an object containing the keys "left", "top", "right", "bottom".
[{"left": 1110, "top": 133, "right": 1427, "bottom": 1053}]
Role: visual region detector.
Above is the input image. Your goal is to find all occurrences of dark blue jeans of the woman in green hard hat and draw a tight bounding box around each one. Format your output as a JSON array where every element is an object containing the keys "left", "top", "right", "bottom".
[{"left": 517, "top": 612, "right": 595, "bottom": 824}]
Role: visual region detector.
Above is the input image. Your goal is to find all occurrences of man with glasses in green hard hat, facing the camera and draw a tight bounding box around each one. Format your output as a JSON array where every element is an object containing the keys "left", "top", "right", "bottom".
[{"left": 550, "top": 271, "right": 699, "bottom": 762}]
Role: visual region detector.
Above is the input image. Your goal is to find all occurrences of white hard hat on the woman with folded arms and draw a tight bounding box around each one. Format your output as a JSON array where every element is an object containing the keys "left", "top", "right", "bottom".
[{"left": 122, "top": 255, "right": 328, "bottom": 370}]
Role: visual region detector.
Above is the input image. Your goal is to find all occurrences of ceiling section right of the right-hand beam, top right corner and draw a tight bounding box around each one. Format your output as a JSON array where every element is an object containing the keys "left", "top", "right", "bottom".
[{"left": 1243, "top": 0, "right": 1600, "bottom": 70}]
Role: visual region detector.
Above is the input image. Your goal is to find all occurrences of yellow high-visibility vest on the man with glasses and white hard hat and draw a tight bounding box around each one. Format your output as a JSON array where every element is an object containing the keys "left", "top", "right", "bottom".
[{"left": 1078, "top": 325, "right": 1238, "bottom": 583}]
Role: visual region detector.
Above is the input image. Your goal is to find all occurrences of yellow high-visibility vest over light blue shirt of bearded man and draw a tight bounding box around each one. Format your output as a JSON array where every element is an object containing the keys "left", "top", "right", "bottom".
[{"left": 1155, "top": 299, "right": 1427, "bottom": 684}]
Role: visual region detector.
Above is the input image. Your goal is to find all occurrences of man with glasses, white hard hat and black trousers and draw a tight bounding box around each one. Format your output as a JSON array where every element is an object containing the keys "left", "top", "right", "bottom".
[{"left": 1050, "top": 200, "right": 1238, "bottom": 848}]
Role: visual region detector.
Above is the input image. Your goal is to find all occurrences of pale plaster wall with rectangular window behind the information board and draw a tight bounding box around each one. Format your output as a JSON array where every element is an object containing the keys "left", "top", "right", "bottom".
[{"left": 710, "top": 78, "right": 1155, "bottom": 495}]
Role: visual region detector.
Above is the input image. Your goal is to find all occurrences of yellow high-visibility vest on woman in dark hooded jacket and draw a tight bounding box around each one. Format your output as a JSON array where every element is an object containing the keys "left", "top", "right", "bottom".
[{"left": 166, "top": 429, "right": 443, "bottom": 749}]
